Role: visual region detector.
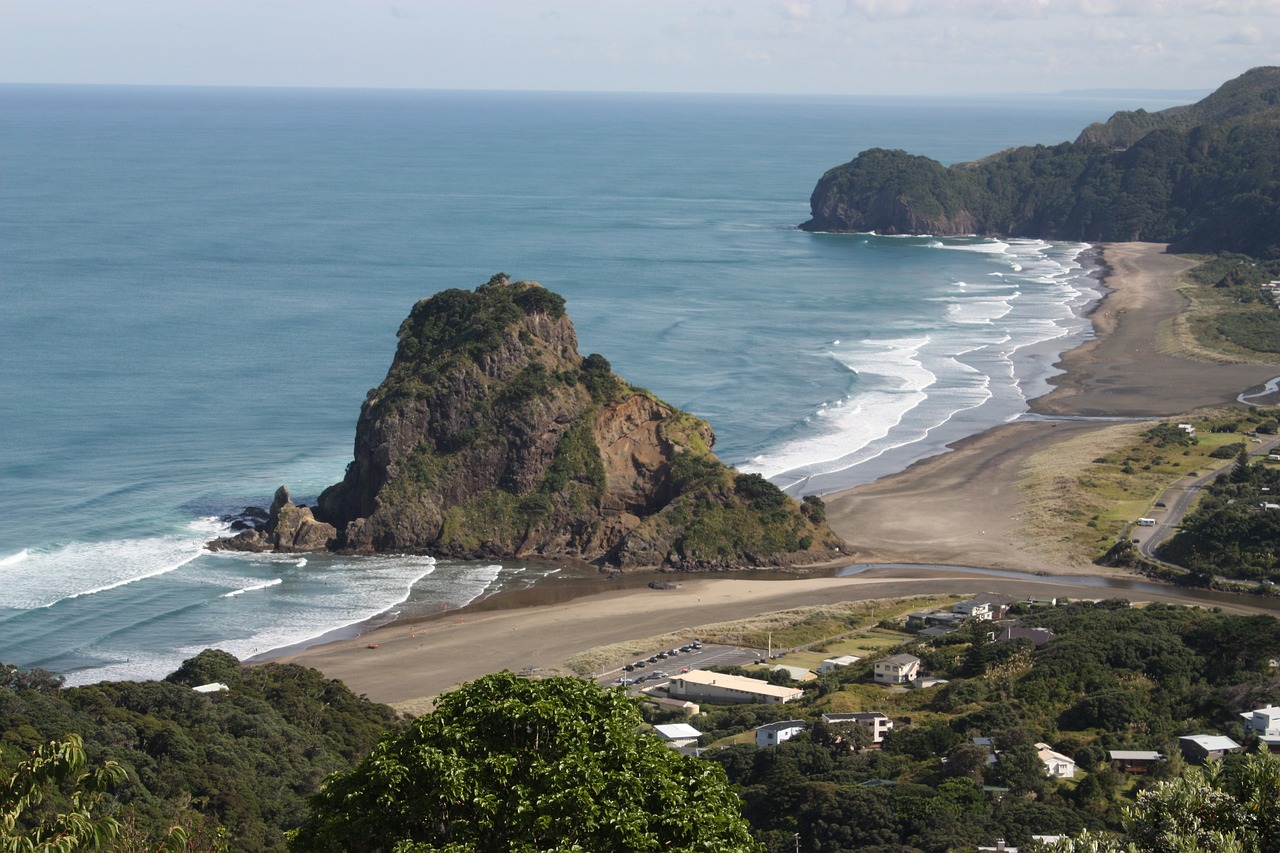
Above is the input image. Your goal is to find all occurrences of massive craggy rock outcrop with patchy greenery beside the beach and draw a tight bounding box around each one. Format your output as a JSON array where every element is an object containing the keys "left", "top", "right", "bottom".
[{"left": 215, "top": 274, "right": 842, "bottom": 569}]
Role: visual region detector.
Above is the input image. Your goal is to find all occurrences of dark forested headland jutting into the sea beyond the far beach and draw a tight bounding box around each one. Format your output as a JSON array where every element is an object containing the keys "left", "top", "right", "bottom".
[{"left": 800, "top": 68, "right": 1280, "bottom": 257}]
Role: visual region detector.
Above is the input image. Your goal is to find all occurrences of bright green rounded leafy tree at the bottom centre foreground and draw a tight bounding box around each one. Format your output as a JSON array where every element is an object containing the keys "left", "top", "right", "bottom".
[{"left": 293, "top": 672, "right": 760, "bottom": 853}]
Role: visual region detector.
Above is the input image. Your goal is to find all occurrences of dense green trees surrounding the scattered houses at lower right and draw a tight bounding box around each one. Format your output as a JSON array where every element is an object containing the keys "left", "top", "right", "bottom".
[{"left": 696, "top": 601, "right": 1280, "bottom": 853}]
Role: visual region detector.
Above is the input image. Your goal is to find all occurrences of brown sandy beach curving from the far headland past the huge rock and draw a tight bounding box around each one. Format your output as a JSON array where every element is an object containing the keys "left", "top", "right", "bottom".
[{"left": 280, "top": 243, "right": 1280, "bottom": 710}]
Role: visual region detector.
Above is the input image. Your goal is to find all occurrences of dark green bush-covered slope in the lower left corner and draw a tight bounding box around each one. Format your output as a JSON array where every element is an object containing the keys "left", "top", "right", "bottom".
[{"left": 0, "top": 651, "right": 394, "bottom": 850}]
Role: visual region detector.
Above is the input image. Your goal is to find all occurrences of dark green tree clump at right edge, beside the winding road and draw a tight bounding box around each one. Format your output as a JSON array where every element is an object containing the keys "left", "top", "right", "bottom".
[{"left": 1160, "top": 450, "right": 1280, "bottom": 580}]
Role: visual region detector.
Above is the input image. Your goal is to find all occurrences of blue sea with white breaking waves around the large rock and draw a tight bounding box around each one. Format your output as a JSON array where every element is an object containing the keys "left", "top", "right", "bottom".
[{"left": 0, "top": 86, "right": 1187, "bottom": 683}]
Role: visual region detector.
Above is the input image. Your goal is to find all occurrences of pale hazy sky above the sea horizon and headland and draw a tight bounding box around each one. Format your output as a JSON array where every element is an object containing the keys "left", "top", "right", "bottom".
[{"left": 0, "top": 0, "right": 1280, "bottom": 96}]
